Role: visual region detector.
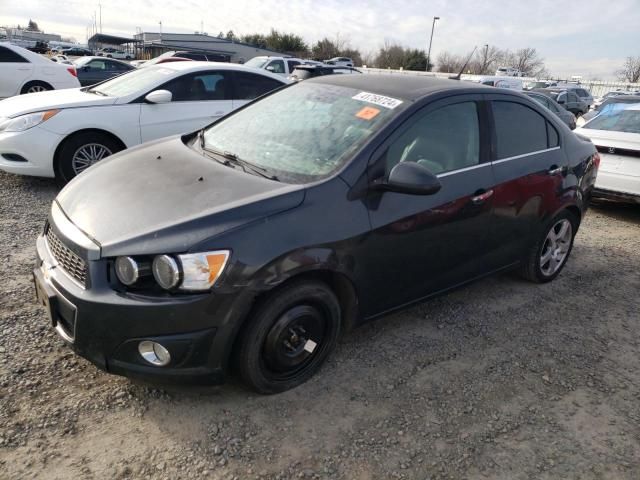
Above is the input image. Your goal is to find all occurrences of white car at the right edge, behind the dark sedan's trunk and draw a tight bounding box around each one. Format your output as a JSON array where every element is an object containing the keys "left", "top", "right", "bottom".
[{"left": 575, "top": 104, "right": 640, "bottom": 204}]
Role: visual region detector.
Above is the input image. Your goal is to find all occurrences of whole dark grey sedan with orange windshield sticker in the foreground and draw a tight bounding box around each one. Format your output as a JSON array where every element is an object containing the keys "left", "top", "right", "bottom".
[{"left": 34, "top": 75, "right": 599, "bottom": 393}]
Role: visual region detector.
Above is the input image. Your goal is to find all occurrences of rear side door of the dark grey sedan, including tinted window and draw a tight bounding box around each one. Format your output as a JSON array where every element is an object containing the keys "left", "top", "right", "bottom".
[{"left": 487, "top": 94, "right": 567, "bottom": 268}]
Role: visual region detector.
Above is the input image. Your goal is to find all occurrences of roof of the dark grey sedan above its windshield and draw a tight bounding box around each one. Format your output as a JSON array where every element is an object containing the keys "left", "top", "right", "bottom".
[{"left": 306, "top": 74, "right": 488, "bottom": 101}]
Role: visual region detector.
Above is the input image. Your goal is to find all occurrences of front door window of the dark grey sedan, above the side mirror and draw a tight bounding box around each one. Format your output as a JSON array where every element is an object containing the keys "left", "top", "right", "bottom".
[{"left": 386, "top": 102, "right": 480, "bottom": 175}]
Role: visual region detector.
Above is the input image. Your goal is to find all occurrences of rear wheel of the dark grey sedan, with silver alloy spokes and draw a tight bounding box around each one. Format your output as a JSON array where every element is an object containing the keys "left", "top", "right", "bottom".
[{"left": 520, "top": 210, "right": 579, "bottom": 283}]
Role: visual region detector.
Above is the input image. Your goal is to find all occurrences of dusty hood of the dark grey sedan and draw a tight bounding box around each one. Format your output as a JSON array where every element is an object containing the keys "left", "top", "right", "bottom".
[{"left": 56, "top": 137, "right": 304, "bottom": 257}]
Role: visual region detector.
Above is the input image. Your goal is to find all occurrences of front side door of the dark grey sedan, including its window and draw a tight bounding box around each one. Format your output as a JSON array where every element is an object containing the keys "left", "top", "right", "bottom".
[{"left": 363, "top": 95, "right": 494, "bottom": 316}]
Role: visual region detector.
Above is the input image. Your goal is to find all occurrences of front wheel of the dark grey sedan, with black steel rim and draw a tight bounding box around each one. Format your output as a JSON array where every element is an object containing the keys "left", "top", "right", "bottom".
[{"left": 235, "top": 281, "right": 341, "bottom": 394}]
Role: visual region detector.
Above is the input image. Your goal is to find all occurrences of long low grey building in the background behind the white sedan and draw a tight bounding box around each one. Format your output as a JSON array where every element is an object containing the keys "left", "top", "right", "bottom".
[{"left": 134, "top": 32, "right": 290, "bottom": 63}]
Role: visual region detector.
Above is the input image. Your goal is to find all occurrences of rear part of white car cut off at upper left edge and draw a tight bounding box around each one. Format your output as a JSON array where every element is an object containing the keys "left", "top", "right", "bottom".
[{"left": 0, "top": 42, "right": 80, "bottom": 99}]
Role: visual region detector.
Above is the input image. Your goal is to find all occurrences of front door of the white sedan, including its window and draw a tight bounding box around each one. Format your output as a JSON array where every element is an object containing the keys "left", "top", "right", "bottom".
[{"left": 140, "top": 70, "right": 233, "bottom": 142}]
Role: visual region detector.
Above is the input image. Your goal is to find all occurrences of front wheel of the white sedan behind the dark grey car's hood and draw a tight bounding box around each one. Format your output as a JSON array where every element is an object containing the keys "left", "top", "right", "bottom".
[{"left": 56, "top": 132, "right": 124, "bottom": 186}]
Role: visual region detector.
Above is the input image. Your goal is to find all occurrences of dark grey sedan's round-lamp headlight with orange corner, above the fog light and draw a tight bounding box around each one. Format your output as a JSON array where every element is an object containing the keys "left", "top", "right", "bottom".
[{"left": 151, "top": 250, "right": 229, "bottom": 291}]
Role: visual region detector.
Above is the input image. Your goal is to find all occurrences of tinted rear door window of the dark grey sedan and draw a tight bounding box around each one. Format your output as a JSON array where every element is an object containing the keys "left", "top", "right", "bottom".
[{"left": 492, "top": 101, "right": 547, "bottom": 160}]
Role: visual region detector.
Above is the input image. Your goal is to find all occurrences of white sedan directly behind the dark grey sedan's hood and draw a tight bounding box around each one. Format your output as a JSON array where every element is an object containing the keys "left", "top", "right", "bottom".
[{"left": 0, "top": 60, "right": 289, "bottom": 183}]
